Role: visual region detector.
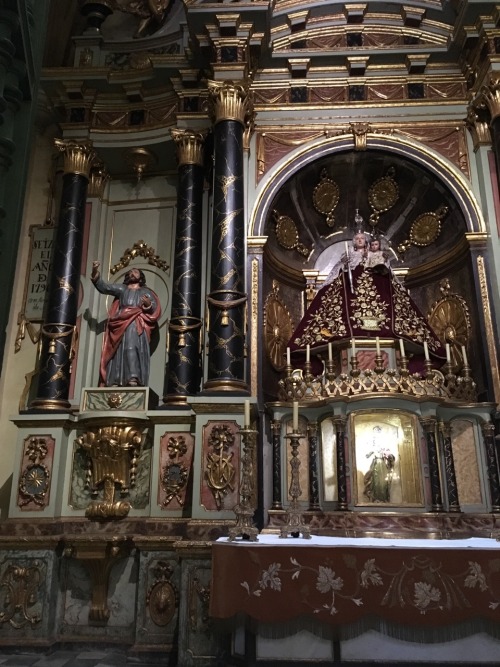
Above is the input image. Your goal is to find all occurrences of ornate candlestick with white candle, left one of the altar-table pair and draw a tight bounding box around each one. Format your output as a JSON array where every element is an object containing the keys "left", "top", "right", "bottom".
[{"left": 228, "top": 401, "right": 259, "bottom": 542}]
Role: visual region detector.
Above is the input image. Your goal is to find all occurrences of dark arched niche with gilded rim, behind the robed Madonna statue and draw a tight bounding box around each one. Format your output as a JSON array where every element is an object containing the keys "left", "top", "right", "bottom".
[{"left": 249, "top": 133, "right": 486, "bottom": 397}]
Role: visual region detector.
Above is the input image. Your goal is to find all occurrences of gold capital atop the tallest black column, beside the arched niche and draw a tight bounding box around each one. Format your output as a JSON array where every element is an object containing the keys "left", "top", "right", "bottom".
[{"left": 208, "top": 81, "right": 253, "bottom": 127}]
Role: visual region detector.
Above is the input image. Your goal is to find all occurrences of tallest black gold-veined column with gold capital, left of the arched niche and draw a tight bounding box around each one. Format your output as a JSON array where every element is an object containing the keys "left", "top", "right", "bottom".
[{"left": 204, "top": 81, "right": 253, "bottom": 391}]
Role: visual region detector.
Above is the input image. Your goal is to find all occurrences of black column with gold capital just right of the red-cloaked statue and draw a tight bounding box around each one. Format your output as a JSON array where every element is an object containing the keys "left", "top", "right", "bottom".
[{"left": 164, "top": 130, "right": 205, "bottom": 405}]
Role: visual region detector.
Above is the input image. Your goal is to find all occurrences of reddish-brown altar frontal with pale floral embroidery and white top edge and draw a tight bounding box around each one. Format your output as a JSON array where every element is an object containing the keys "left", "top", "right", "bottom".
[{"left": 210, "top": 535, "right": 500, "bottom": 634}]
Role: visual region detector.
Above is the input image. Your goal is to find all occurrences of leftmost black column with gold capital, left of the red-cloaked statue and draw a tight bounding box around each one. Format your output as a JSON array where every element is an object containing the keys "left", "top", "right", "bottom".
[{"left": 31, "top": 139, "right": 95, "bottom": 410}]
